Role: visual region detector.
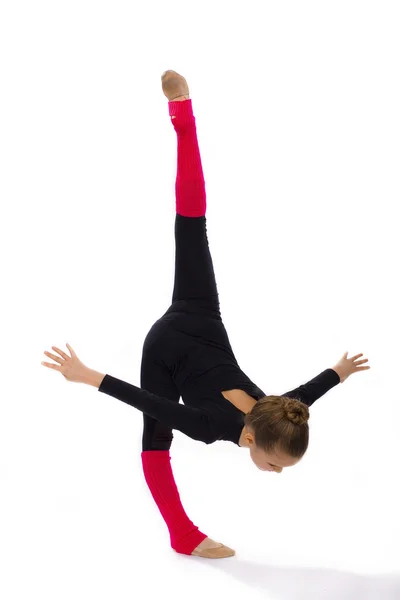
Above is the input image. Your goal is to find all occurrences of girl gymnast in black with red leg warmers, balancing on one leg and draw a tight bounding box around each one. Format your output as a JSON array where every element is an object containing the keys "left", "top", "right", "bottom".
[{"left": 42, "top": 71, "right": 370, "bottom": 558}]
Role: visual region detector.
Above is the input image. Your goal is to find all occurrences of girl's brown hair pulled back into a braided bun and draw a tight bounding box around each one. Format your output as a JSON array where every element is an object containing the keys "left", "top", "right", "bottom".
[{"left": 244, "top": 396, "right": 310, "bottom": 458}]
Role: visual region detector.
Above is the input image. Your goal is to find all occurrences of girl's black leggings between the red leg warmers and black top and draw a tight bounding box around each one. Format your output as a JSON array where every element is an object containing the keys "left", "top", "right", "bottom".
[{"left": 140, "top": 213, "right": 221, "bottom": 451}]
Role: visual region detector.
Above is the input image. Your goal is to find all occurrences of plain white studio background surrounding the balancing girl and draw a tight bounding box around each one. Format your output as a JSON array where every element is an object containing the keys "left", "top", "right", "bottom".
[{"left": 0, "top": 0, "right": 400, "bottom": 600}]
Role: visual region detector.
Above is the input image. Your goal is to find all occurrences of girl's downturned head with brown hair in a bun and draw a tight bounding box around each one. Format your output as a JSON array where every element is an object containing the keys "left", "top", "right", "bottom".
[{"left": 240, "top": 396, "right": 310, "bottom": 473}]
